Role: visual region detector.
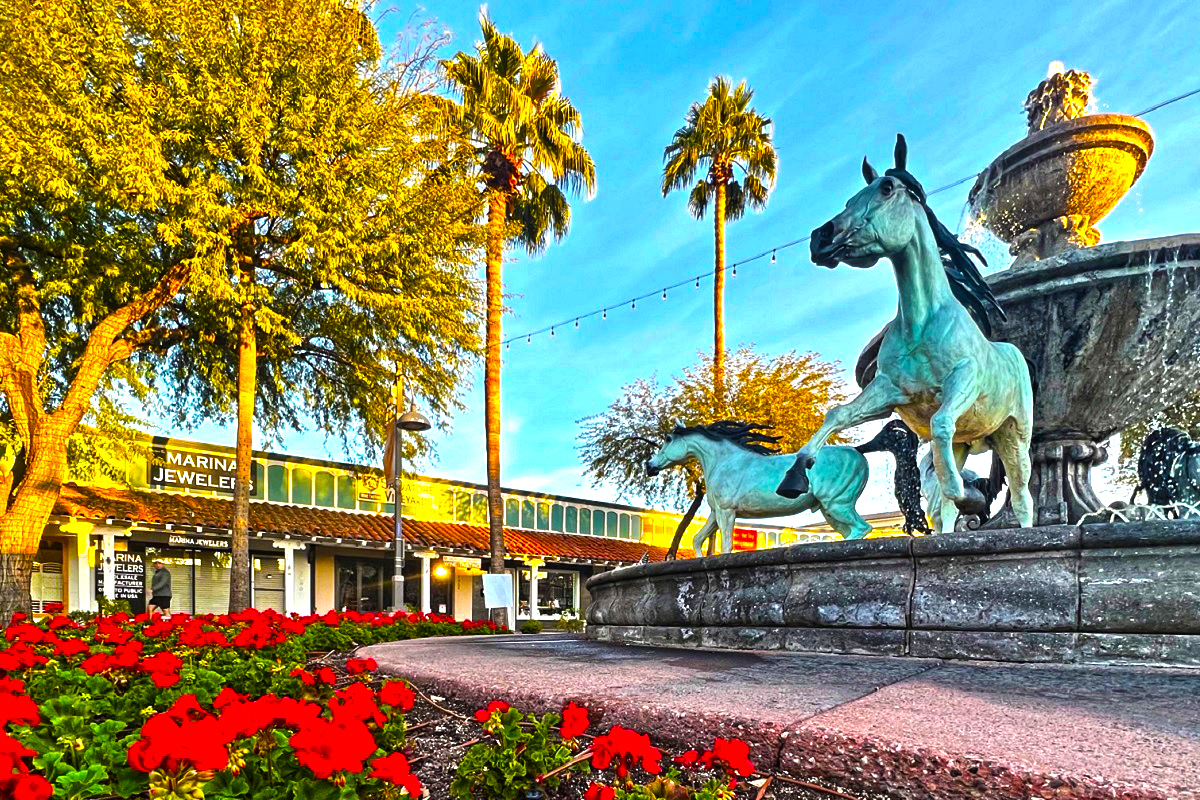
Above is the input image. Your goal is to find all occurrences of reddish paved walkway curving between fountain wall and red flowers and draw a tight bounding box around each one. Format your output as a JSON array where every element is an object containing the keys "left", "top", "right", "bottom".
[{"left": 365, "top": 634, "right": 1200, "bottom": 800}]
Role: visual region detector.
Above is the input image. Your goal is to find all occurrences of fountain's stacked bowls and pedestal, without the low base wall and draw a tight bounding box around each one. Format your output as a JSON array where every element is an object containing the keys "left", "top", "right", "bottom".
[{"left": 970, "top": 70, "right": 1200, "bottom": 527}]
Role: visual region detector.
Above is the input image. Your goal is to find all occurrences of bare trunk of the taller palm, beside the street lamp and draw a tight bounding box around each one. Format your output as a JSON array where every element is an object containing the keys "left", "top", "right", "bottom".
[{"left": 484, "top": 191, "right": 509, "bottom": 626}]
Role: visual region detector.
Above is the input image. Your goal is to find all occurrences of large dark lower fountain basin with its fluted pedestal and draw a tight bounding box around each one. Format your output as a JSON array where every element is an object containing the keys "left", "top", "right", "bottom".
[{"left": 988, "top": 234, "right": 1200, "bottom": 524}]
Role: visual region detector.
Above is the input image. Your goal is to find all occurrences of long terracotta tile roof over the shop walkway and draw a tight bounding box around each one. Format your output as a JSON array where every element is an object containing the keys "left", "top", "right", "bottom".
[{"left": 54, "top": 483, "right": 691, "bottom": 563}]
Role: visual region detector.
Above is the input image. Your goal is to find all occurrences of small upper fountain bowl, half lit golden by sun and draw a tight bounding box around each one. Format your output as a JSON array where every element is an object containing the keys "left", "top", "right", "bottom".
[{"left": 970, "top": 114, "right": 1154, "bottom": 258}]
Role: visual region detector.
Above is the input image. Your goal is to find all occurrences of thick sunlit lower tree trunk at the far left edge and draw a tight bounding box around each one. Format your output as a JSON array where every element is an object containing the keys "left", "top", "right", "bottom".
[{"left": 0, "top": 417, "right": 70, "bottom": 625}]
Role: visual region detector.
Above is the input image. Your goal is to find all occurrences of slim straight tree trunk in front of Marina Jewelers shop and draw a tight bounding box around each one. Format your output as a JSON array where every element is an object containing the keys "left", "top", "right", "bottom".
[{"left": 229, "top": 265, "right": 258, "bottom": 614}]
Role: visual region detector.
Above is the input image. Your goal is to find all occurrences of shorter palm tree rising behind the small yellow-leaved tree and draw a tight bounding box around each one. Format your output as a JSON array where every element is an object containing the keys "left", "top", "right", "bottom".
[{"left": 662, "top": 77, "right": 776, "bottom": 401}]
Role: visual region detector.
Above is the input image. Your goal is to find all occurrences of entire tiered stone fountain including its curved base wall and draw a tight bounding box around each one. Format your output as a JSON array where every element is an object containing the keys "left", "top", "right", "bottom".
[{"left": 588, "top": 71, "right": 1200, "bottom": 667}]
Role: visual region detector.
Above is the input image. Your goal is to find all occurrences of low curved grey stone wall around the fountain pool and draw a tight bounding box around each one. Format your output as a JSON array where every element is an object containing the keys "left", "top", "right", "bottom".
[{"left": 587, "top": 521, "right": 1200, "bottom": 666}]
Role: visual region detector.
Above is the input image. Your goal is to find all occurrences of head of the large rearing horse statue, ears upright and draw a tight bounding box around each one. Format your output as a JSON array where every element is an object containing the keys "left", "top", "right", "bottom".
[{"left": 809, "top": 136, "right": 925, "bottom": 267}]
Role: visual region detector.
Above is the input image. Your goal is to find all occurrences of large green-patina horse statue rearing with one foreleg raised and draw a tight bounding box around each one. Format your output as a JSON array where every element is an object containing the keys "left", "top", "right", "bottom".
[{"left": 776, "top": 136, "right": 1033, "bottom": 528}]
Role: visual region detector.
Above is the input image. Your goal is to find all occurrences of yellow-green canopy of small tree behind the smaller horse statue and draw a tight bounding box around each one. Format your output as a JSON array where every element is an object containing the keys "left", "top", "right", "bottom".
[{"left": 578, "top": 347, "right": 847, "bottom": 510}]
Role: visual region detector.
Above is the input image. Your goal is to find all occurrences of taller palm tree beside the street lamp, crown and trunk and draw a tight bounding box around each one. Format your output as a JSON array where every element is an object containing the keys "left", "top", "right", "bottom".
[{"left": 442, "top": 13, "right": 595, "bottom": 624}]
